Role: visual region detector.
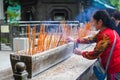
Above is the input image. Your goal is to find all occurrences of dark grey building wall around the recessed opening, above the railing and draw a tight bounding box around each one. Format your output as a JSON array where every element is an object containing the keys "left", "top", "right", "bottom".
[{"left": 21, "top": 0, "right": 82, "bottom": 20}]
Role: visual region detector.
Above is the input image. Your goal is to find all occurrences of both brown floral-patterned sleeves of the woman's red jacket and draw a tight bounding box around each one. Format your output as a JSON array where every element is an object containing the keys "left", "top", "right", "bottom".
[{"left": 82, "top": 33, "right": 110, "bottom": 59}]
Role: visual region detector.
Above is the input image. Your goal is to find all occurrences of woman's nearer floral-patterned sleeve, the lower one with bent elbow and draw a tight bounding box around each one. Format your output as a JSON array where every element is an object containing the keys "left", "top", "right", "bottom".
[{"left": 81, "top": 35, "right": 110, "bottom": 59}]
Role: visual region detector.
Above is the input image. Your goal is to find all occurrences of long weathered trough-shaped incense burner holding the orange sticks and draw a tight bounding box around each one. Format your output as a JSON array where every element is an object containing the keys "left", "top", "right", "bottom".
[{"left": 10, "top": 42, "right": 74, "bottom": 78}]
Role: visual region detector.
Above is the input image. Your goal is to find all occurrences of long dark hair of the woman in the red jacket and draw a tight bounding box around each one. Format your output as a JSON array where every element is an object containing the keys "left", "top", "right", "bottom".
[{"left": 93, "top": 10, "right": 115, "bottom": 29}]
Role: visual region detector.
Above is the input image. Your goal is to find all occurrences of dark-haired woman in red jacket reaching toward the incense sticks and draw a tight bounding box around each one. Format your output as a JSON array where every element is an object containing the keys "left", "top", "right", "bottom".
[{"left": 68, "top": 10, "right": 120, "bottom": 80}]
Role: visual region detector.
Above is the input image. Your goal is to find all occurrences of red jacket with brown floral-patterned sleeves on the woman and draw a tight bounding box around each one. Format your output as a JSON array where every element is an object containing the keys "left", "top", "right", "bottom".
[{"left": 82, "top": 28, "right": 120, "bottom": 74}]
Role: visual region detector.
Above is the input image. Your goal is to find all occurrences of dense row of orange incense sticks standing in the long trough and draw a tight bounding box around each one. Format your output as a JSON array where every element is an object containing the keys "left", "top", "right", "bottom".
[{"left": 16, "top": 21, "right": 79, "bottom": 55}]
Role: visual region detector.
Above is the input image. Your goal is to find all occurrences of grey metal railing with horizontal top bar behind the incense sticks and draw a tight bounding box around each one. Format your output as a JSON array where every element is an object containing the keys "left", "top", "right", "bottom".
[{"left": 0, "top": 21, "right": 79, "bottom": 50}]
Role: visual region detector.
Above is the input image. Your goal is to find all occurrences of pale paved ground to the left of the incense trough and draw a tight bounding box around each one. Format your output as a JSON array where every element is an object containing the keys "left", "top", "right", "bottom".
[{"left": 0, "top": 44, "right": 12, "bottom": 80}]
